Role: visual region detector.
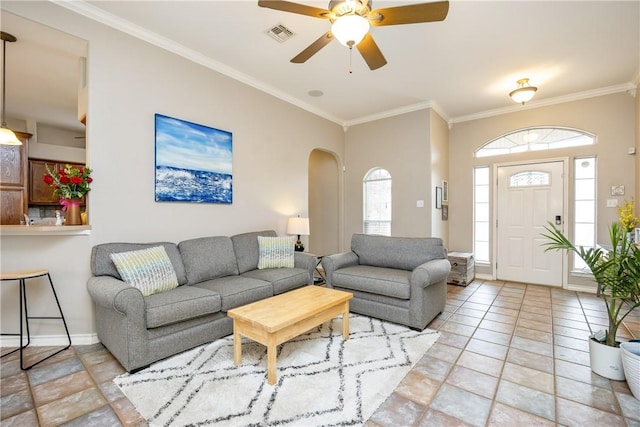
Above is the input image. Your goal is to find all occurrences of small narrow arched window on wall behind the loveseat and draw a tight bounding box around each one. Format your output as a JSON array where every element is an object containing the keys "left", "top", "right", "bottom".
[{"left": 362, "top": 168, "right": 391, "bottom": 236}]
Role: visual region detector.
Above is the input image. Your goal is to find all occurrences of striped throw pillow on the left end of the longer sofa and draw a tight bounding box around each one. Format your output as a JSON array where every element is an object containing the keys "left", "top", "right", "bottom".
[{"left": 111, "top": 246, "right": 178, "bottom": 296}]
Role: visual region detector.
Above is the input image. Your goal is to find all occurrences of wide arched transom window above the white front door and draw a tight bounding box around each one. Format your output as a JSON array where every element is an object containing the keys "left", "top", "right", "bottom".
[{"left": 475, "top": 127, "right": 596, "bottom": 157}]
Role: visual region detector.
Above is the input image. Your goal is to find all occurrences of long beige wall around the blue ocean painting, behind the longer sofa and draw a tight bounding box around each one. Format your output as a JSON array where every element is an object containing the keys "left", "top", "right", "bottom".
[{"left": 0, "top": 1, "right": 344, "bottom": 344}]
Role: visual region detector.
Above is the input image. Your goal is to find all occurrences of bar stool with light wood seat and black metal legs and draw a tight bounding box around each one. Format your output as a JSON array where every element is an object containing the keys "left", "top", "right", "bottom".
[{"left": 0, "top": 270, "right": 71, "bottom": 371}]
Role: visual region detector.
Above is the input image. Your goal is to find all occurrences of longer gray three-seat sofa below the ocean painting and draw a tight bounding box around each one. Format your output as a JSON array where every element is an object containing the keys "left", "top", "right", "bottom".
[{"left": 87, "top": 230, "right": 317, "bottom": 372}]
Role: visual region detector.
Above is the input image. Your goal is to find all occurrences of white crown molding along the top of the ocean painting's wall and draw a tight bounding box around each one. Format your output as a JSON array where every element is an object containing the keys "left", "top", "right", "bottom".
[{"left": 50, "top": 0, "right": 344, "bottom": 126}]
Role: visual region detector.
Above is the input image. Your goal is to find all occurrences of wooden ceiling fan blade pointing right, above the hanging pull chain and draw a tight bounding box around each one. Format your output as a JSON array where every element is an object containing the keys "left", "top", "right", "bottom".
[{"left": 369, "top": 1, "right": 449, "bottom": 27}]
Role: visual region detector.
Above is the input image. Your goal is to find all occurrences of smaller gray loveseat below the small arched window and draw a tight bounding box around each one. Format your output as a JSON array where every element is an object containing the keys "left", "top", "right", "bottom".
[{"left": 322, "top": 234, "right": 451, "bottom": 330}]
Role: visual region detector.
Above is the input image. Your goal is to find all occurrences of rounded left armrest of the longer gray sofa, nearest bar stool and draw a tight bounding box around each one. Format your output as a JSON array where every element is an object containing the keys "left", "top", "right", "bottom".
[{"left": 87, "top": 276, "right": 145, "bottom": 322}]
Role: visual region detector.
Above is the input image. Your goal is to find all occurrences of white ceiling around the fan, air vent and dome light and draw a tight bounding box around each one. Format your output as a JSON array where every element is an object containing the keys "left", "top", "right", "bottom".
[{"left": 2, "top": 0, "right": 640, "bottom": 131}]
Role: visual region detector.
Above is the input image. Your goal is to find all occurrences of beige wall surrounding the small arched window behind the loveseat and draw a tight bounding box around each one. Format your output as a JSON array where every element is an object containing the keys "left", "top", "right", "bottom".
[{"left": 344, "top": 109, "right": 440, "bottom": 248}]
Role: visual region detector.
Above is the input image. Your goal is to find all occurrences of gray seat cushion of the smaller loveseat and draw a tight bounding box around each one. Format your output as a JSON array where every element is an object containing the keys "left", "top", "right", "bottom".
[{"left": 331, "top": 265, "right": 411, "bottom": 299}]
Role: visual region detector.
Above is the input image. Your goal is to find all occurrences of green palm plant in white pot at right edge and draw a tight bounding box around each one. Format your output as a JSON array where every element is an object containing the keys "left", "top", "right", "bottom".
[{"left": 543, "top": 207, "right": 640, "bottom": 381}]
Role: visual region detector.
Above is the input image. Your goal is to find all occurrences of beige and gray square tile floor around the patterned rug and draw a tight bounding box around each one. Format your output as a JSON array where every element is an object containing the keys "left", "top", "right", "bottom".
[{"left": 0, "top": 280, "right": 640, "bottom": 427}]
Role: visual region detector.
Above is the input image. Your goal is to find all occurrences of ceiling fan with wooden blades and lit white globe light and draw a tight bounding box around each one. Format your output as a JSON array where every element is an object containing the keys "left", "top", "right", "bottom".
[{"left": 258, "top": 0, "right": 449, "bottom": 70}]
